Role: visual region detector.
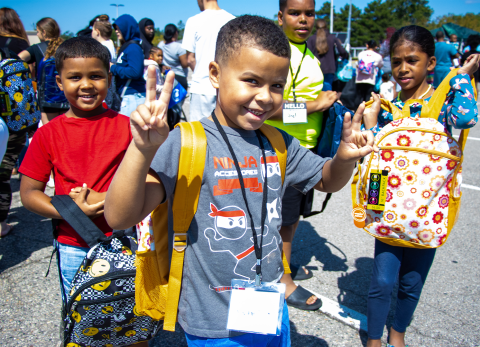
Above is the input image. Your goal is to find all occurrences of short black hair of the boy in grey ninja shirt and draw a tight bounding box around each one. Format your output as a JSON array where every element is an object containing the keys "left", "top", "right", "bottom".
[{"left": 215, "top": 15, "right": 290, "bottom": 63}]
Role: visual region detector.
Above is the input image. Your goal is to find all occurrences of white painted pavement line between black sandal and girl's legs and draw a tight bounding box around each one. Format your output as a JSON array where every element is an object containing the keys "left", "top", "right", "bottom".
[{"left": 294, "top": 287, "right": 367, "bottom": 331}]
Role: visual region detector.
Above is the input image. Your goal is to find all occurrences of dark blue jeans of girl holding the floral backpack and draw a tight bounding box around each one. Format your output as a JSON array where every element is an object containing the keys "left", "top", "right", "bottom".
[{"left": 367, "top": 240, "right": 436, "bottom": 339}]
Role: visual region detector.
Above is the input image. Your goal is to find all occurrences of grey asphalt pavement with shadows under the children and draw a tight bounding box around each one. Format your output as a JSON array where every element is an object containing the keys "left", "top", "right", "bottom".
[{"left": 0, "top": 104, "right": 480, "bottom": 347}]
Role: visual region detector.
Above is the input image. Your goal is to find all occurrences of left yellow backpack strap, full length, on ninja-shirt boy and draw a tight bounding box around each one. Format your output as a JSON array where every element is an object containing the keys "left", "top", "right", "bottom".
[{"left": 163, "top": 121, "right": 207, "bottom": 331}]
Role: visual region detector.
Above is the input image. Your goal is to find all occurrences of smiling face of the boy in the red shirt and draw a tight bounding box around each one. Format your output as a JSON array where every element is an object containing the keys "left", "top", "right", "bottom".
[{"left": 57, "top": 58, "right": 111, "bottom": 118}]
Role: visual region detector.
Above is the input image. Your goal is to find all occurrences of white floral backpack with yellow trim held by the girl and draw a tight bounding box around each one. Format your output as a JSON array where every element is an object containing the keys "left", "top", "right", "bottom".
[{"left": 352, "top": 70, "right": 476, "bottom": 248}]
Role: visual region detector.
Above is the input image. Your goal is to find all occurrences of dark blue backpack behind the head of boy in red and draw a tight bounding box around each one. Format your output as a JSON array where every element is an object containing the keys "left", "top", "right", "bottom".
[{"left": 37, "top": 57, "right": 70, "bottom": 109}]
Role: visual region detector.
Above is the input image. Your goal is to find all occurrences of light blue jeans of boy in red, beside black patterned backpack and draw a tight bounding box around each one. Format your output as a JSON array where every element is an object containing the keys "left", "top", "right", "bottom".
[{"left": 53, "top": 240, "right": 90, "bottom": 303}]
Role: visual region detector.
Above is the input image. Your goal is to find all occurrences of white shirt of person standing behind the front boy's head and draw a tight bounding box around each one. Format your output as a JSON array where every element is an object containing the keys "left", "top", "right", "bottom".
[{"left": 182, "top": 10, "right": 235, "bottom": 95}]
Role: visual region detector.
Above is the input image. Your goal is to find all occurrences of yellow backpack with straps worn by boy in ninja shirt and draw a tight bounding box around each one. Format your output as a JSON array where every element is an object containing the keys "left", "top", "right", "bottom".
[{"left": 135, "top": 121, "right": 290, "bottom": 331}]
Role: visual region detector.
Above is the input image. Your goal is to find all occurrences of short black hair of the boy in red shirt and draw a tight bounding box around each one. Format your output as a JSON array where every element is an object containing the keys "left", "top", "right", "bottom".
[{"left": 55, "top": 36, "right": 110, "bottom": 74}]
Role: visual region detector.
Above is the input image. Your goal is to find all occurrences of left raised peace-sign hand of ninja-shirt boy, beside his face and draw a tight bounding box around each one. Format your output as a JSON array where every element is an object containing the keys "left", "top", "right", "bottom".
[{"left": 130, "top": 66, "right": 175, "bottom": 150}]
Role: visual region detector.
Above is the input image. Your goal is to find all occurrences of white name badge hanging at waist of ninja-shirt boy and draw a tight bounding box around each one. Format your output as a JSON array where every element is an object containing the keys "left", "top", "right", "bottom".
[{"left": 227, "top": 280, "right": 286, "bottom": 336}]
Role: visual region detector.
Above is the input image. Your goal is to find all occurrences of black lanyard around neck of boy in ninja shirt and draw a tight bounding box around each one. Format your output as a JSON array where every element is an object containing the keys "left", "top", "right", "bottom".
[{"left": 212, "top": 110, "right": 268, "bottom": 286}]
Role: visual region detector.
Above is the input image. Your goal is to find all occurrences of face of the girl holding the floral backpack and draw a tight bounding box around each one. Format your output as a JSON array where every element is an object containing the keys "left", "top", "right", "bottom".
[{"left": 391, "top": 42, "right": 436, "bottom": 90}]
